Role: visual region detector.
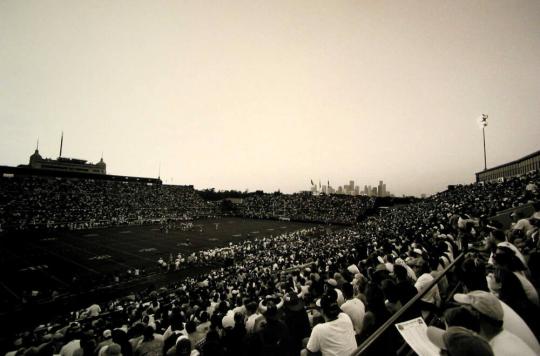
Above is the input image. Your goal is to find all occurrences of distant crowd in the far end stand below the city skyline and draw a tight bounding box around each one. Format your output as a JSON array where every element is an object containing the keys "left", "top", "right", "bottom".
[{"left": 238, "top": 193, "right": 375, "bottom": 224}]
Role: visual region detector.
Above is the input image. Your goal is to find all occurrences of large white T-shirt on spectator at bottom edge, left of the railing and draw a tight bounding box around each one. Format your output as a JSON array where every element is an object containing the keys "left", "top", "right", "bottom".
[{"left": 307, "top": 313, "right": 356, "bottom": 356}]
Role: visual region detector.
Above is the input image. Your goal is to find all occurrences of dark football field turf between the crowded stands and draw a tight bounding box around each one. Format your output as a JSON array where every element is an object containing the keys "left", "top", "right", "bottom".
[{"left": 0, "top": 217, "right": 320, "bottom": 305}]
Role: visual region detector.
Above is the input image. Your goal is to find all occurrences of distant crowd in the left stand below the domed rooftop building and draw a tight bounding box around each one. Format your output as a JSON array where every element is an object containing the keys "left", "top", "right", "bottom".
[{"left": 0, "top": 176, "right": 215, "bottom": 230}]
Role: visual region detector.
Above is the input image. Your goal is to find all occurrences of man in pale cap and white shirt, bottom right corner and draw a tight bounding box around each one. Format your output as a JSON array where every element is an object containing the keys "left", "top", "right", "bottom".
[{"left": 454, "top": 290, "right": 536, "bottom": 356}]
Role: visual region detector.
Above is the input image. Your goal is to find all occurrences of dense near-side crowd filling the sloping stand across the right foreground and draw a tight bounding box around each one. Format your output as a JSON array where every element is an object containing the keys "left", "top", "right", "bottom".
[{"left": 1, "top": 173, "right": 540, "bottom": 356}]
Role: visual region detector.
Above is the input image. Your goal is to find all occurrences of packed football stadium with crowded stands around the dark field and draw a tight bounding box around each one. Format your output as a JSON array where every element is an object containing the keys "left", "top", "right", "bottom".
[{"left": 0, "top": 145, "right": 540, "bottom": 354}]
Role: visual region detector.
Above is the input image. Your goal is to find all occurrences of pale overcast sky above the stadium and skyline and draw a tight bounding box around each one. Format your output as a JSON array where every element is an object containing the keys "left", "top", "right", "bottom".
[{"left": 0, "top": 0, "right": 540, "bottom": 195}]
